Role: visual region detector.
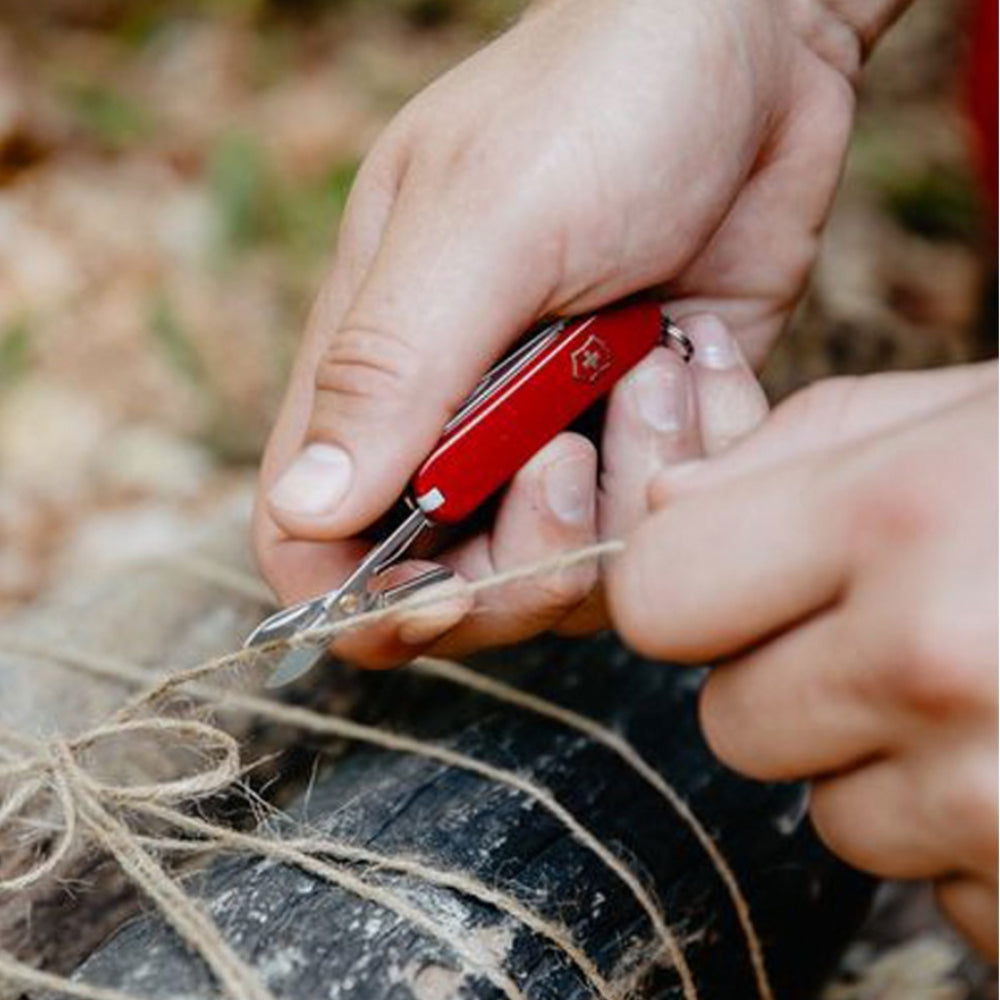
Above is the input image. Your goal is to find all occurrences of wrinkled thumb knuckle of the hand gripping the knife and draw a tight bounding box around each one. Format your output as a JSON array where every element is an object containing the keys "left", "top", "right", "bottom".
[{"left": 315, "top": 325, "right": 424, "bottom": 418}]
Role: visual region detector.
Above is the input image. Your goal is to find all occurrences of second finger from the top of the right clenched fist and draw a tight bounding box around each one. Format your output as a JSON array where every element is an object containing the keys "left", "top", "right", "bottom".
[{"left": 699, "top": 609, "right": 893, "bottom": 781}]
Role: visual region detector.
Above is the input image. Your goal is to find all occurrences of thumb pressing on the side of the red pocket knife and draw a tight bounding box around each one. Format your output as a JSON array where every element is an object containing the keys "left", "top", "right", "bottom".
[{"left": 268, "top": 164, "right": 564, "bottom": 540}]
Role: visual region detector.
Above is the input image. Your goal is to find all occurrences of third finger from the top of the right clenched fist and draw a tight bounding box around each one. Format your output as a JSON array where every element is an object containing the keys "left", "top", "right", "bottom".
[{"left": 809, "top": 758, "right": 980, "bottom": 879}]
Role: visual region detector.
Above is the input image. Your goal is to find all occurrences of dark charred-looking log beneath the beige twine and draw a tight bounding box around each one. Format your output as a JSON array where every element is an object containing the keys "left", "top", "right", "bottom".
[{"left": 66, "top": 637, "right": 871, "bottom": 1000}]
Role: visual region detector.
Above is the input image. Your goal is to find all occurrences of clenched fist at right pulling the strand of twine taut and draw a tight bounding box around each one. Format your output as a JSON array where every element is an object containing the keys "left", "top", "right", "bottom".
[{"left": 609, "top": 365, "right": 997, "bottom": 955}]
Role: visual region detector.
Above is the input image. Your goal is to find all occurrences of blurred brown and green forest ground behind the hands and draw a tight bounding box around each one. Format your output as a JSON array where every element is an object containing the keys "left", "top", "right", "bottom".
[{"left": 0, "top": 0, "right": 996, "bottom": 614}]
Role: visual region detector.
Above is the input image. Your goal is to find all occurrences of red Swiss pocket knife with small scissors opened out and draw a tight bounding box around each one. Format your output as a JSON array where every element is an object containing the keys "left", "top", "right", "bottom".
[{"left": 245, "top": 299, "right": 693, "bottom": 687}]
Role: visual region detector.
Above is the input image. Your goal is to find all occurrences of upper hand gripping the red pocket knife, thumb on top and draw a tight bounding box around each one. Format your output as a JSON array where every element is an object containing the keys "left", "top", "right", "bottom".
[{"left": 255, "top": 0, "right": 859, "bottom": 665}]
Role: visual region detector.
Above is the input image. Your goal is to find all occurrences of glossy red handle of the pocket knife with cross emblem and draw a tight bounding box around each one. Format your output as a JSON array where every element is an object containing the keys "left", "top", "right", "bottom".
[{"left": 413, "top": 300, "right": 661, "bottom": 524}]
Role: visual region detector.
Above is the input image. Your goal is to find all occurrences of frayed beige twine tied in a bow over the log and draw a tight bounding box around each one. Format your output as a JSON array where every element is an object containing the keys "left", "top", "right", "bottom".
[{"left": 0, "top": 541, "right": 773, "bottom": 1000}]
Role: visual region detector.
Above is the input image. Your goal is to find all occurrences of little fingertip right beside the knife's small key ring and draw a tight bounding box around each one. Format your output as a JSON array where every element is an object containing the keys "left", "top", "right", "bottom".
[{"left": 684, "top": 313, "right": 769, "bottom": 456}]
